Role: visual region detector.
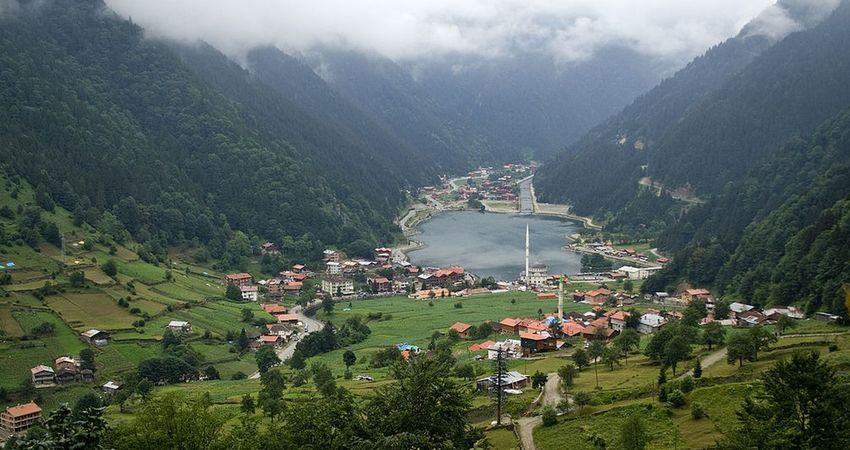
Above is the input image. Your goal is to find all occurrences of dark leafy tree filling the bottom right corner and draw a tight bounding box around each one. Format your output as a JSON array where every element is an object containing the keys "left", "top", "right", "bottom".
[{"left": 726, "top": 352, "right": 850, "bottom": 449}]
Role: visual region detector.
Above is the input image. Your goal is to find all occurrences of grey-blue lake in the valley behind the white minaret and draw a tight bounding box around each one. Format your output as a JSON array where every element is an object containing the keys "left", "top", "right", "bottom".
[{"left": 408, "top": 211, "right": 581, "bottom": 281}]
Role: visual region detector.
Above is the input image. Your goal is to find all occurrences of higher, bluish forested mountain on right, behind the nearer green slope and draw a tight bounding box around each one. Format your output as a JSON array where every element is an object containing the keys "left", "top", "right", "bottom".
[{"left": 535, "top": 0, "right": 848, "bottom": 228}]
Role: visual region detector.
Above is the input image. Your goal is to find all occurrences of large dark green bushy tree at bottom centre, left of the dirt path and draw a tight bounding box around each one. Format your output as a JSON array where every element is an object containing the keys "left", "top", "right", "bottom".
[{"left": 364, "top": 356, "right": 478, "bottom": 448}]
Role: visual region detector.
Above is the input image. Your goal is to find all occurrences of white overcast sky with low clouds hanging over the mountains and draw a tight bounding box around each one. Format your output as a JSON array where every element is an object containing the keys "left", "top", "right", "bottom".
[{"left": 106, "top": 0, "right": 774, "bottom": 62}]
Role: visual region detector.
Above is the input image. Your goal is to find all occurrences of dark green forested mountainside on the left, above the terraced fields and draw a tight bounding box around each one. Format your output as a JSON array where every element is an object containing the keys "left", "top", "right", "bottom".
[{"left": 0, "top": 0, "right": 410, "bottom": 260}]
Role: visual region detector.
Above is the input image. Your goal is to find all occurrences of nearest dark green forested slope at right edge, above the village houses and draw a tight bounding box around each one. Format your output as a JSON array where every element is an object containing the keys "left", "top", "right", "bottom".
[{"left": 643, "top": 106, "right": 850, "bottom": 316}]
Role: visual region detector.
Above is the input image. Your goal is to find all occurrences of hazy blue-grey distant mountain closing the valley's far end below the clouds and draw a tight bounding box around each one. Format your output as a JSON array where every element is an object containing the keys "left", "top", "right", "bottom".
[{"left": 410, "top": 46, "right": 670, "bottom": 160}]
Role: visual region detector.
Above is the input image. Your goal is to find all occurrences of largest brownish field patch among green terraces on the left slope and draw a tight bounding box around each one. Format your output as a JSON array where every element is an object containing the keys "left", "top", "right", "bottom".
[{"left": 47, "top": 293, "right": 138, "bottom": 331}]
